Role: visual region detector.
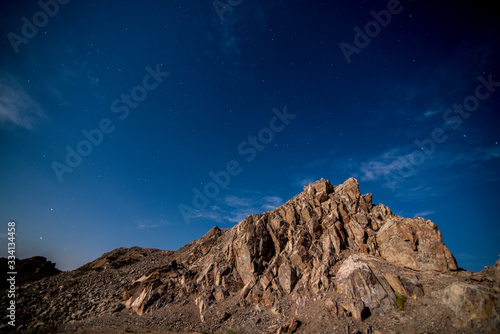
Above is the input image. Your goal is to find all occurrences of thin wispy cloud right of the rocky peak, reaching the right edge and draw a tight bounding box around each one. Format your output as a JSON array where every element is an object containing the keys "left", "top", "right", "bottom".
[{"left": 358, "top": 142, "right": 500, "bottom": 201}]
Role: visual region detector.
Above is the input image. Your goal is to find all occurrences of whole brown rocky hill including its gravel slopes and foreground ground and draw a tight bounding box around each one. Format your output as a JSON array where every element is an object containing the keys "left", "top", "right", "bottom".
[{"left": 1, "top": 178, "right": 500, "bottom": 333}]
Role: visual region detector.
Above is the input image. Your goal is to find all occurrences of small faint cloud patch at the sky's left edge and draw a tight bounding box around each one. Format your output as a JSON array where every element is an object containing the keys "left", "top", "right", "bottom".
[{"left": 0, "top": 73, "right": 46, "bottom": 131}]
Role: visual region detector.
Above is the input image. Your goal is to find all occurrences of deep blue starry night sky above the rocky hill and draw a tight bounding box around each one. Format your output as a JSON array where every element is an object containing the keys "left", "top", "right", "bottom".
[{"left": 0, "top": 0, "right": 500, "bottom": 271}]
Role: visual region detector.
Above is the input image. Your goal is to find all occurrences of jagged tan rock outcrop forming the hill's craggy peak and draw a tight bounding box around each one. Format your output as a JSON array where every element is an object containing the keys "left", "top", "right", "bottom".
[{"left": 124, "top": 178, "right": 457, "bottom": 319}]
